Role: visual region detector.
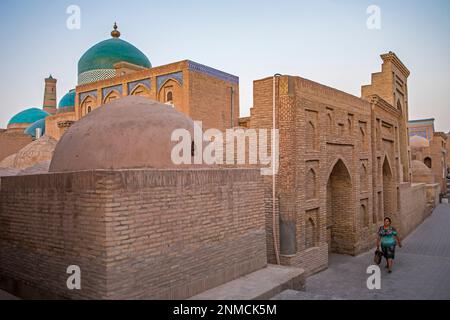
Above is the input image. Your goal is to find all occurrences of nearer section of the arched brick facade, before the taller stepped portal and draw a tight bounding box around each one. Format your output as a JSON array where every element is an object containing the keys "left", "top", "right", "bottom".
[{"left": 250, "top": 76, "right": 376, "bottom": 273}]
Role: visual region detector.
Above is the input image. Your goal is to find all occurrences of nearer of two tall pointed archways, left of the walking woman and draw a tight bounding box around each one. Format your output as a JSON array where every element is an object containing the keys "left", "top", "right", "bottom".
[{"left": 327, "top": 160, "right": 355, "bottom": 254}]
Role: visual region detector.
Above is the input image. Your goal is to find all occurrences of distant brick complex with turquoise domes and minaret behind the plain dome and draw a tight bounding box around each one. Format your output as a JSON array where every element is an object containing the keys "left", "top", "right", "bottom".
[{"left": 0, "top": 25, "right": 240, "bottom": 161}]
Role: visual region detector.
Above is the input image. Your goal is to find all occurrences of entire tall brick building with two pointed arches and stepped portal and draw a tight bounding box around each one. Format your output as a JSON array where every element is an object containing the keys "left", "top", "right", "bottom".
[{"left": 248, "top": 53, "right": 436, "bottom": 273}]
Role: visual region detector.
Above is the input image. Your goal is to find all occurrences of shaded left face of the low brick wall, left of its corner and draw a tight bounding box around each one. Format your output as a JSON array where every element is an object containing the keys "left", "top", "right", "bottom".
[{"left": 0, "top": 172, "right": 108, "bottom": 299}]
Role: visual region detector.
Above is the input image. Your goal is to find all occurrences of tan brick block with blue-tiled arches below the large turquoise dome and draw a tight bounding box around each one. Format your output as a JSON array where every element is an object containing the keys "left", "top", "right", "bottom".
[{"left": 75, "top": 60, "right": 240, "bottom": 130}]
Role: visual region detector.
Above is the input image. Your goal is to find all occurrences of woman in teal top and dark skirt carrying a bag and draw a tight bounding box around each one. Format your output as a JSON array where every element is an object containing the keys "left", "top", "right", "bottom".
[{"left": 377, "top": 218, "right": 402, "bottom": 273}]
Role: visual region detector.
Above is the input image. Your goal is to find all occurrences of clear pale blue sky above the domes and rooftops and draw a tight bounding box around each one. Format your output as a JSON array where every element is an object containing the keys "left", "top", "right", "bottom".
[{"left": 0, "top": 0, "right": 450, "bottom": 131}]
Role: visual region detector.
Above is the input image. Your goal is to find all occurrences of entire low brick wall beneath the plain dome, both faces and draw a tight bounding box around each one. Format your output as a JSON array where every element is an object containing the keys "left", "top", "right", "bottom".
[{"left": 0, "top": 169, "right": 267, "bottom": 299}]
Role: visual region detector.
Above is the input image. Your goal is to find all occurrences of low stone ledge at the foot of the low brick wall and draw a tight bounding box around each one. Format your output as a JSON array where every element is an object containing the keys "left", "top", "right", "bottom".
[{"left": 189, "top": 265, "right": 305, "bottom": 300}]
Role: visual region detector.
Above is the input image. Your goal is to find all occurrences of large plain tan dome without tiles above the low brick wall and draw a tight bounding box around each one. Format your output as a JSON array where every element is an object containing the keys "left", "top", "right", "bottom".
[{"left": 50, "top": 96, "right": 200, "bottom": 172}]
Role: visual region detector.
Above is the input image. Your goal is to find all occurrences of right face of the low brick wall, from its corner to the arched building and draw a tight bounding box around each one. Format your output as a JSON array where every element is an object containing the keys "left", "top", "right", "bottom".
[{"left": 107, "top": 169, "right": 267, "bottom": 299}]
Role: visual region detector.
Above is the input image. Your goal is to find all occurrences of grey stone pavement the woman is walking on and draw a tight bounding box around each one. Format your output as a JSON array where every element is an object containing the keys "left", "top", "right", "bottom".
[{"left": 274, "top": 204, "right": 450, "bottom": 300}]
